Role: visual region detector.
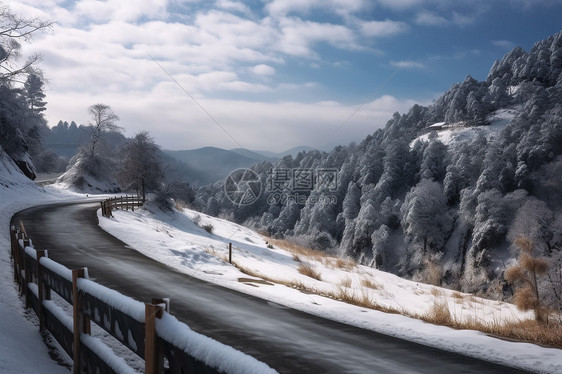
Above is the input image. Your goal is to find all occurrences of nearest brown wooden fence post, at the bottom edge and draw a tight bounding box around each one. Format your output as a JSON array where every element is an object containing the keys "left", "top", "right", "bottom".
[{"left": 144, "top": 304, "right": 164, "bottom": 374}]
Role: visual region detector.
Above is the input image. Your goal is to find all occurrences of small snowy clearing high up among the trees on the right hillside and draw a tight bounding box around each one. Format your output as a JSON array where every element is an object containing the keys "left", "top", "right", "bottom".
[{"left": 410, "top": 107, "right": 521, "bottom": 147}]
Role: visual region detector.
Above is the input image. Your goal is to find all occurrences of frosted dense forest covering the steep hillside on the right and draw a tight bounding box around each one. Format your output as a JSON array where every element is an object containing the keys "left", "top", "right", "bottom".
[{"left": 195, "top": 32, "right": 562, "bottom": 308}]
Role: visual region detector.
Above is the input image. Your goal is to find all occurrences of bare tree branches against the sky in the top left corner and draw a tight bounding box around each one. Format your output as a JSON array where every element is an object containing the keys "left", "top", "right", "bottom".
[{"left": 0, "top": 5, "right": 54, "bottom": 81}]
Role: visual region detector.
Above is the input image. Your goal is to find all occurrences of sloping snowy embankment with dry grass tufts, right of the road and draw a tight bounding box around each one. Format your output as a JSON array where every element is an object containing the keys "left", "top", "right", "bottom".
[{"left": 98, "top": 206, "right": 562, "bottom": 373}]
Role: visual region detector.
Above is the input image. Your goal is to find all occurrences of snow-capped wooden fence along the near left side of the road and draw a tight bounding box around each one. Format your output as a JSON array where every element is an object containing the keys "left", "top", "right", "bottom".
[{"left": 10, "top": 222, "right": 276, "bottom": 374}]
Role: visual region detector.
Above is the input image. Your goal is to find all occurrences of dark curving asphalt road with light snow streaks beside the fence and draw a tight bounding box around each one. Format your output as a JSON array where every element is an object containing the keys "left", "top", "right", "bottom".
[{"left": 14, "top": 203, "right": 519, "bottom": 374}]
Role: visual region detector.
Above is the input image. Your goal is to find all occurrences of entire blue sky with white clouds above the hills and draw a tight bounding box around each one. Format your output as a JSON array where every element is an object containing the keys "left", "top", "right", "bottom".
[{"left": 12, "top": 0, "right": 562, "bottom": 151}]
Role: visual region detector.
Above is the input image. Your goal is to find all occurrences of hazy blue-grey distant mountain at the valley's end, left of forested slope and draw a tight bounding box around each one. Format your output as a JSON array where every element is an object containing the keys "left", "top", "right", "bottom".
[{"left": 164, "top": 147, "right": 271, "bottom": 186}]
